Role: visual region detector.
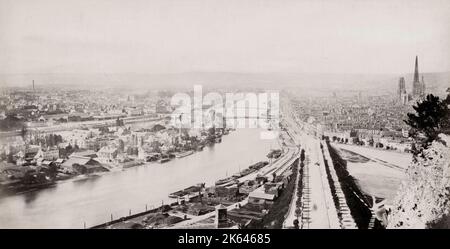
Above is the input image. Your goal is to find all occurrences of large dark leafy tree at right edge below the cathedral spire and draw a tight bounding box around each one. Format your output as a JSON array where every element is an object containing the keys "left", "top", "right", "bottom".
[{"left": 404, "top": 94, "right": 450, "bottom": 148}]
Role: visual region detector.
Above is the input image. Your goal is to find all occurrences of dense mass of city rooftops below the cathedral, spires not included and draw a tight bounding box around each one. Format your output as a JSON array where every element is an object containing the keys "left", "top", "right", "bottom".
[{"left": 293, "top": 95, "right": 413, "bottom": 151}]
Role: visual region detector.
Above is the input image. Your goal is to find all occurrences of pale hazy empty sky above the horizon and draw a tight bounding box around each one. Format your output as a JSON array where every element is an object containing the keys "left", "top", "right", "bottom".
[{"left": 0, "top": 0, "right": 450, "bottom": 73}]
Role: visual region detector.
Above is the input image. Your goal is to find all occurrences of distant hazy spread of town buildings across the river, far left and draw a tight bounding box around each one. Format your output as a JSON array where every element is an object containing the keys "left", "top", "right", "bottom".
[{"left": 0, "top": 88, "right": 170, "bottom": 130}]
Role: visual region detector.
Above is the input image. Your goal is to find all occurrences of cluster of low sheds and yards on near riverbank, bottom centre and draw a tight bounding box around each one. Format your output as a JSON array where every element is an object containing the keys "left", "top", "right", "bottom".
[{"left": 103, "top": 156, "right": 296, "bottom": 229}]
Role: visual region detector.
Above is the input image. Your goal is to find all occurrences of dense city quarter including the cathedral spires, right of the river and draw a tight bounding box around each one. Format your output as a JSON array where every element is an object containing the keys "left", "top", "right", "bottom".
[{"left": 291, "top": 57, "right": 434, "bottom": 151}]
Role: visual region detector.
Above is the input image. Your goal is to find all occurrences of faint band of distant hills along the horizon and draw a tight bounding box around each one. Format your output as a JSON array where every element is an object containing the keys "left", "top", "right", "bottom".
[{"left": 0, "top": 72, "right": 450, "bottom": 92}]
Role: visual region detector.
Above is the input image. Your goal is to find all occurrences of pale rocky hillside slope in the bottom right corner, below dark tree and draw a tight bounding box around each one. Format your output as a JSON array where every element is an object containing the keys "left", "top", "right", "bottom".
[{"left": 388, "top": 134, "right": 450, "bottom": 229}]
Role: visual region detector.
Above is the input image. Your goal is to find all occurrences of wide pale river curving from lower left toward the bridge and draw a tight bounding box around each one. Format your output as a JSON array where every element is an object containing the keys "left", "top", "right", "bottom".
[{"left": 0, "top": 129, "right": 279, "bottom": 228}]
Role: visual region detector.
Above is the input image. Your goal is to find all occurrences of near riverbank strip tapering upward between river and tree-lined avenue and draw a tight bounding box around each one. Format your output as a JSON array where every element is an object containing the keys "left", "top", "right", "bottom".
[{"left": 92, "top": 130, "right": 299, "bottom": 229}]
